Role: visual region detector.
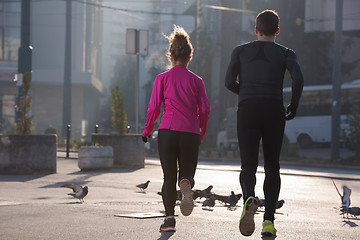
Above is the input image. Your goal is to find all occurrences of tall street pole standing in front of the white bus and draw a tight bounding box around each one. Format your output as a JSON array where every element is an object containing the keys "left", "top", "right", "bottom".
[{"left": 331, "top": 0, "right": 343, "bottom": 160}]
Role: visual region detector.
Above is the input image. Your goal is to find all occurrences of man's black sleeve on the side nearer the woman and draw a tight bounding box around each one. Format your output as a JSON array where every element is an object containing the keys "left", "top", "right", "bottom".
[{"left": 225, "top": 47, "right": 240, "bottom": 94}]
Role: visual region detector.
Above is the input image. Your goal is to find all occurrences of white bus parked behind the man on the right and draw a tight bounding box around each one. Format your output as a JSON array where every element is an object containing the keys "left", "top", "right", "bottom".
[{"left": 283, "top": 80, "right": 360, "bottom": 148}]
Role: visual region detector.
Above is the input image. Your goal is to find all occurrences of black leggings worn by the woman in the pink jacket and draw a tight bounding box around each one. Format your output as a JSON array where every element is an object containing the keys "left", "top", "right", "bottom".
[{"left": 158, "top": 129, "right": 200, "bottom": 216}]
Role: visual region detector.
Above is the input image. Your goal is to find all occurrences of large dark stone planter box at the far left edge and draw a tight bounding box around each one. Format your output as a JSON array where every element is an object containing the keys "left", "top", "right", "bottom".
[{"left": 0, "top": 134, "right": 57, "bottom": 174}]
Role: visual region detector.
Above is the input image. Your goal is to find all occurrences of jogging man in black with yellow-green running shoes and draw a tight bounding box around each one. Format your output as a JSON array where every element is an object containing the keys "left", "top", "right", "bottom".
[{"left": 225, "top": 10, "right": 304, "bottom": 236}]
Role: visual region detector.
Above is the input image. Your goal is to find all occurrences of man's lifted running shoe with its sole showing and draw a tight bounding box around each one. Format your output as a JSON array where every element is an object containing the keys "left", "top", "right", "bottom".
[{"left": 239, "top": 197, "right": 259, "bottom": 236}]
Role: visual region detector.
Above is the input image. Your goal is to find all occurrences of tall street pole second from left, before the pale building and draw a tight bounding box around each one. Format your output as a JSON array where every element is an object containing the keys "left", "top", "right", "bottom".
[{"left": 62, "top": 0, "right": 71, "bottom": 137}]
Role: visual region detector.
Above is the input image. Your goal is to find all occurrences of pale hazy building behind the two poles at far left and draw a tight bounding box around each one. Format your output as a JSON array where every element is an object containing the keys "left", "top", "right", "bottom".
[{"left": 0, "top": 0, "right": 103, "bottom": 140}]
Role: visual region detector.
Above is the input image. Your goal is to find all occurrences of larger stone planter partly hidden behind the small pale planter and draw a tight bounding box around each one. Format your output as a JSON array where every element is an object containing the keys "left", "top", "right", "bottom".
[{"left": 91, "top": 133, "right": 145, "bottom": 168}]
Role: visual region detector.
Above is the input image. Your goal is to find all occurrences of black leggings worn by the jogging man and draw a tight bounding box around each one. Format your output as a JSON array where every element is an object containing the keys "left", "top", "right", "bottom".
[{"left": 237, "top": 99, "right": 285, "bottom": 221}]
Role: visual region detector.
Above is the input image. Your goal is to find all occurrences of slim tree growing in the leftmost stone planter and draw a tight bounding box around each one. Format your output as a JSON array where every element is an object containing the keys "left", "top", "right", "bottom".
[{"left": 16, "top": 72, "right": 33, "bottom": 134}]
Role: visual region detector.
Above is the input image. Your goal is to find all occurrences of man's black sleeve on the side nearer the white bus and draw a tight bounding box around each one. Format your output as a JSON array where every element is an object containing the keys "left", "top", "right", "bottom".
[{"left": 286, "top": 49, "right": 304, "bottom": 108}]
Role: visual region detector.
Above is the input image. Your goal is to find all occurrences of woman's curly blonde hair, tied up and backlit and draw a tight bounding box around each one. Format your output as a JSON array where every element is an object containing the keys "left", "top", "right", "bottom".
[{"left": 164, "top": 25, "right": 193, "bottom": 63}]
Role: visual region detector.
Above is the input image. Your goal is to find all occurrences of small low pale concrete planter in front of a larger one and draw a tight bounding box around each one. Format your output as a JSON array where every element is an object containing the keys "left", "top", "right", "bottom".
[{"left": 78, "top": 146, "right": 114, "bottom": 171}]
